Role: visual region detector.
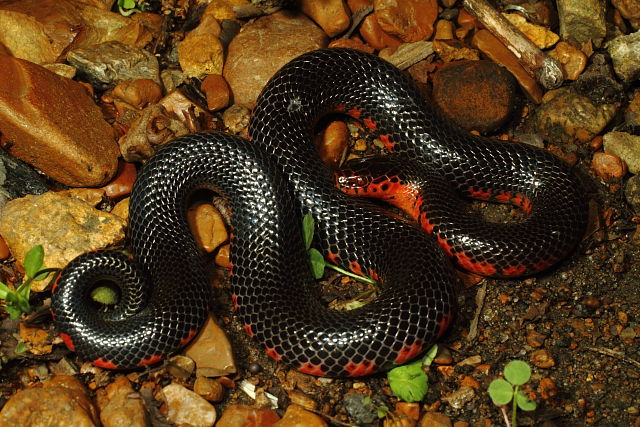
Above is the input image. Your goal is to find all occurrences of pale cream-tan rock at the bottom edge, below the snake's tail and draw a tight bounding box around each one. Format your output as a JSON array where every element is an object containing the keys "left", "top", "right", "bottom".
[{"left": 160, "top": 383, "right": 216, "bottom": 427}]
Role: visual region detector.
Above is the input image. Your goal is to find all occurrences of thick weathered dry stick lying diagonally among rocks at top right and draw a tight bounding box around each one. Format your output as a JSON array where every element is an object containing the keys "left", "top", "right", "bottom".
[{"left": 463, "top": 0, "right": 564, "bottom": 90}]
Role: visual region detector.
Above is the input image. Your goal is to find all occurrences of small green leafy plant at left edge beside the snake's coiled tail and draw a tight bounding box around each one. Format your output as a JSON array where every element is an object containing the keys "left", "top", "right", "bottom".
[{"left": 0, "top": 245, "right": 58, "bottom": 320}]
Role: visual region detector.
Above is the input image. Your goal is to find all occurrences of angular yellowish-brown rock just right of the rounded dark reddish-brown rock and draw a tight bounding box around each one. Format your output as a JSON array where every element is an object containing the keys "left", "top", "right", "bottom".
[{"left": 525, "top": 87, "right": 617, "bottom": 143}]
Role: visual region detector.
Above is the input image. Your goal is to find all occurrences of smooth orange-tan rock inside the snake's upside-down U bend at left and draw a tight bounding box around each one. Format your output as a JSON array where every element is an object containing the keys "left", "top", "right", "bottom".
[{"left": 187, "top": 204, "right": 229, "bottom": 252}]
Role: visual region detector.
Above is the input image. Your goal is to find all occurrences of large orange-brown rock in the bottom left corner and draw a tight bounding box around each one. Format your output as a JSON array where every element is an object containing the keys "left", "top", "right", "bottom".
[{"left": 0, "top": 375, "right": 100, "bottom": 427}]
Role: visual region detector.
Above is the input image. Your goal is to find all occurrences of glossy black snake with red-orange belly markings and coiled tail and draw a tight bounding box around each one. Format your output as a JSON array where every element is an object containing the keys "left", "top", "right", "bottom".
[{"left": 52, "top": 48, "right": 587, "bottom": 377}]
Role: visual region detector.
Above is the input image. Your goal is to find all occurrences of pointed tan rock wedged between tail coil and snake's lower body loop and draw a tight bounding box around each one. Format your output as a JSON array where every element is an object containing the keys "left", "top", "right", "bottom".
[{"left": 184, "top": 316, "right": 236, "bottom": 377}]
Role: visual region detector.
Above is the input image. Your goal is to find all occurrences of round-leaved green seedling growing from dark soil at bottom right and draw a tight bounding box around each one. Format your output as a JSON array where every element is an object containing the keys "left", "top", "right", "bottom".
[{"left": 487, "top": 360, "right": 536, "bottom": 427}]
